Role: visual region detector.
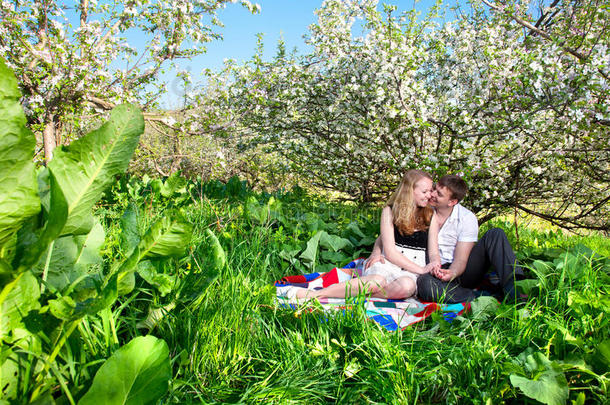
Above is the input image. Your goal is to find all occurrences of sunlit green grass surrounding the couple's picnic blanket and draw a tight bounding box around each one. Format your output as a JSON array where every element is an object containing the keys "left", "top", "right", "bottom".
[{"left": 66, "top": 178, "right": 610, "bottom": 404}]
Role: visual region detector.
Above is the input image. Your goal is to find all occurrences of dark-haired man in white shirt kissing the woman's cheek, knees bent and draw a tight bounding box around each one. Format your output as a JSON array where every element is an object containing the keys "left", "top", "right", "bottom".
[{"left": 369, "top": 175, "right": 523, "bottom": 303}]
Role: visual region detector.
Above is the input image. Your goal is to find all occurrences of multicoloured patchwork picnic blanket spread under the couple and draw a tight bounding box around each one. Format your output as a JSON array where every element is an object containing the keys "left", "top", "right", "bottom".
[{"left": 275, "top": 259, "right": 470, "bottom": 331}]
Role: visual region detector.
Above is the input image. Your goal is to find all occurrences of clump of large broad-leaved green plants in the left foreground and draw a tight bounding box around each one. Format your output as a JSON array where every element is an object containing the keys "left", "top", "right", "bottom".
[{"left": 0, "top": 63, "right": 192, "bottom": 403}]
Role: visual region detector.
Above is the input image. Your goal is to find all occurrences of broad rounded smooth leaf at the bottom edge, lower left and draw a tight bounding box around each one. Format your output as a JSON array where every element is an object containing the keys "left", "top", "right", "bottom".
[{"left": 78, "top": 336, "right": 171, "bottom": 405}]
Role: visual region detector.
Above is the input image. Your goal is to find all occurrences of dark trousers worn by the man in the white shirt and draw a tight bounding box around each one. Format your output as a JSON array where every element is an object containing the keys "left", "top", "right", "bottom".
[{"left": 417, "top": 228, "right": 523, "bottom": 303}]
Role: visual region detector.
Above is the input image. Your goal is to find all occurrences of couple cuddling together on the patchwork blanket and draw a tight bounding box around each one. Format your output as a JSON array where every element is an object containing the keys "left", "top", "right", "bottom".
[{"left": 280, "top": 170, "right": 523, "bottom": 303}]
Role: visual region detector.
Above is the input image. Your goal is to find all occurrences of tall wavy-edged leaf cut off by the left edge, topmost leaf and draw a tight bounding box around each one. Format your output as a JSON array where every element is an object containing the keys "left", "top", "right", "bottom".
[{"left": 0, "top": 59, "right": 40, "bottom": 254}]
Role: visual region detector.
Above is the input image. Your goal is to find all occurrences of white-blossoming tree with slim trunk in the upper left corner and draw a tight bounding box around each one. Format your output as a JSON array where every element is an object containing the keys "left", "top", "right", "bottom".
[{"left": 0, "top": 0, "right": 258, "bottom": 161}]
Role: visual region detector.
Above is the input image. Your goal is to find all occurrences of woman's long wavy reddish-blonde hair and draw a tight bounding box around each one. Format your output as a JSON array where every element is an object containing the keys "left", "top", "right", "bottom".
[{"left": 387, "top": 169, "right": 433, "bottom": 235}]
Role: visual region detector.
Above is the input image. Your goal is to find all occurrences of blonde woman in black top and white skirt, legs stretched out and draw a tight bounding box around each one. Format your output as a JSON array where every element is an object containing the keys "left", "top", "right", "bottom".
[{"left": 278, "top": 170, "right": 433, "bottom": 299}]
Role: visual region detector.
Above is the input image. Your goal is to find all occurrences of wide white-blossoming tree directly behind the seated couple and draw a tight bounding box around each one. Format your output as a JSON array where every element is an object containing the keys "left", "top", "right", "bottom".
[{"left": 207, "top": 1, "right": 610, "bottom": 230}]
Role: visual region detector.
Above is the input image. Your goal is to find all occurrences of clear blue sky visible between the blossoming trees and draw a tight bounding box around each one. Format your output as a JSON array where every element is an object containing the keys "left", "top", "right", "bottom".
[{"left": 160, "top": 0, "right": 448, "bottom": 108}]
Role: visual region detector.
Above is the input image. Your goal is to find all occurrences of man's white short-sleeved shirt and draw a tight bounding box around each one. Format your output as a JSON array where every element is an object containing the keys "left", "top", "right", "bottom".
[{"left": 438, "top": 204, "right": 479, "bottom": 264}]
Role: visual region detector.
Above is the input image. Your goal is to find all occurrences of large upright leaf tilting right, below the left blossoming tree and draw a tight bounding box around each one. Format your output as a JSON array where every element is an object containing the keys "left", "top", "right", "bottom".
[{"left": 48, "top": 105, "right": 144, "bottom": 235}]
